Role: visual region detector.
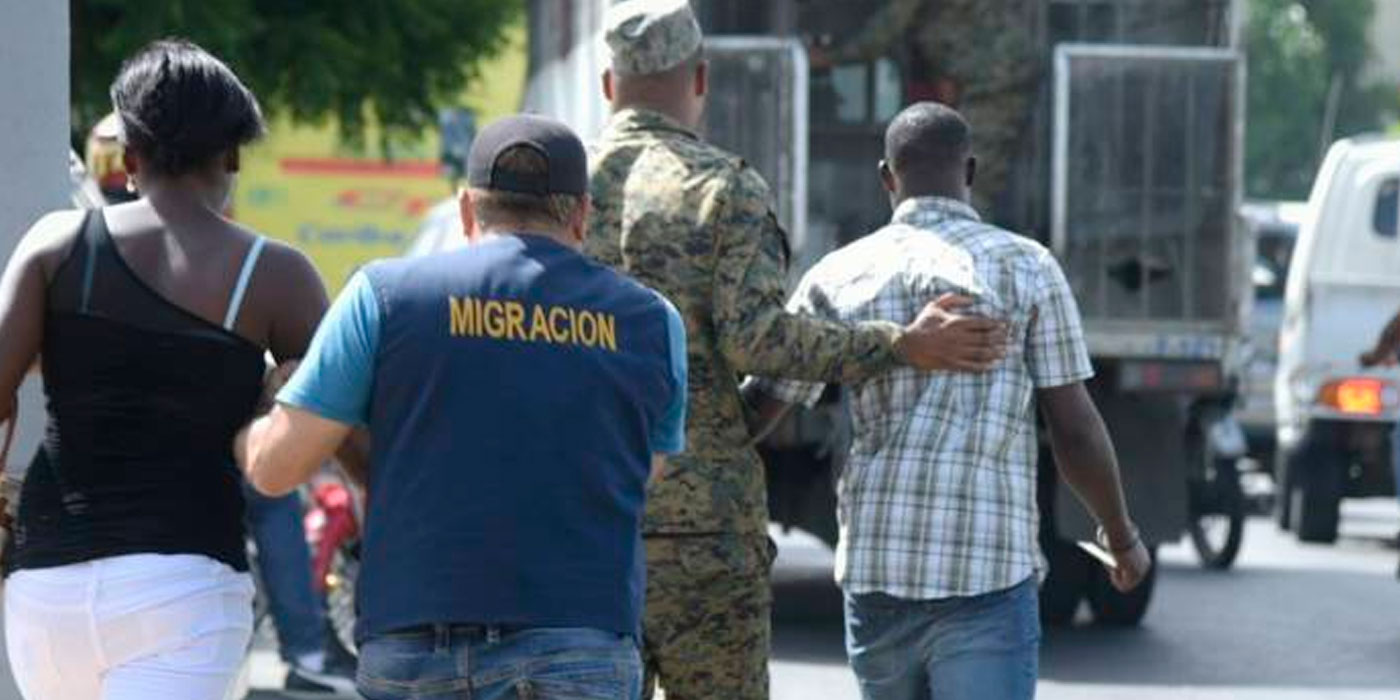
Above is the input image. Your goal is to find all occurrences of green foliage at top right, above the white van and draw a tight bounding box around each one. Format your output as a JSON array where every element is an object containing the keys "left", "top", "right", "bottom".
[{"left": 1245, "top": 0, "right": 1400, "bottom": 199}]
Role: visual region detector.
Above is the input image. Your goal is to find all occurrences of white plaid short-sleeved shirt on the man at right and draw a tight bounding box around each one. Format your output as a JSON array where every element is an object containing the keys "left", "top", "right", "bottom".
[{"left": 764, "top": 197, "right": 1093, "bottom": 599}]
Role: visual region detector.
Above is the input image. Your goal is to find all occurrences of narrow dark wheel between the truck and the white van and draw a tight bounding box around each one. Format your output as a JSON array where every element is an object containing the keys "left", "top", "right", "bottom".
[{"left": 1189, "top": 449, "right": 1245, "bottom": 568}]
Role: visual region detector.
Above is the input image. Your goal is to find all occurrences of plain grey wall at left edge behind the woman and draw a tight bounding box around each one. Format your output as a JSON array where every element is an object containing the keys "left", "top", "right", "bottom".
[{"left": 0, "top": 0, "right": 69, "bottom": 473}]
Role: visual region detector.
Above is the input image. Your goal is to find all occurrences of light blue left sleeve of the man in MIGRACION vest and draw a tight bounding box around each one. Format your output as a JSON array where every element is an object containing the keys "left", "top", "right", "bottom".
[{"left": 277, "top": 272, "right": 379, "bottom": 426}]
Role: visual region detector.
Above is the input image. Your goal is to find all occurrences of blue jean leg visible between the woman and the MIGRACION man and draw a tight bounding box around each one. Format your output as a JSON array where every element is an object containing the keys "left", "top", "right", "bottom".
[{"left": 245, "top": 489, "right": 326, "bottom": 662}]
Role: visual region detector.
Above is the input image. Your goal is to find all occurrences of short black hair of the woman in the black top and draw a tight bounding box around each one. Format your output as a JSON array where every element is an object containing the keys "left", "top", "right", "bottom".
[{"left": 111, "top": 39, "right": 263, "bottom": 176}]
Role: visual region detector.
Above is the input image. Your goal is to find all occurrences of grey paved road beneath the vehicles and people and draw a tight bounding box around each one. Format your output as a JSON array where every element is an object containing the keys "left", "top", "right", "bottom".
[{"left": 0, "top": 500, "right": 1400, "bottom": 700}]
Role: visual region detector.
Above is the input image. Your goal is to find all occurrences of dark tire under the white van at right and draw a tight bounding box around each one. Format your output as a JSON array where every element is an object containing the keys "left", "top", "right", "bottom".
[{"left": 1287, "top": 423, "right": 1348, "bottom": 545}]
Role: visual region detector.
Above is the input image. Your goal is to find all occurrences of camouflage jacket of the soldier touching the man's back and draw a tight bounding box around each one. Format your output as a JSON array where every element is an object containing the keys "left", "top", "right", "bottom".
[{"left": 585, "top": 111, "right": 899, "bottom": 533}]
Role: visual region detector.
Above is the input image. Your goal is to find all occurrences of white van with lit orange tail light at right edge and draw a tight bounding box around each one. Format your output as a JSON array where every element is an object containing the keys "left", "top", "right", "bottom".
[{"left": 1274, "top": 137, "right": 1400, "bottom": 542}]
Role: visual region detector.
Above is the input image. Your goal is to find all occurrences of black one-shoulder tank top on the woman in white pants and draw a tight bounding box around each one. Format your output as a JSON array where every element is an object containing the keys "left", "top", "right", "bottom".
[{"left": 10, "top": 211, "right": 263, "bottom": 571}]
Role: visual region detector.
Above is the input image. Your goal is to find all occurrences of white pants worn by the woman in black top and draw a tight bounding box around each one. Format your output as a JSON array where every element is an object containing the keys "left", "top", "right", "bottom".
[{"left": 4, "top": 554, "right": 253, "bottom": 700}]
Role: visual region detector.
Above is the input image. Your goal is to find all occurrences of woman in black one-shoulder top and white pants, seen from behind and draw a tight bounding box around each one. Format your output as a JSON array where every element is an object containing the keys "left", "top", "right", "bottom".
[{"left": 0, "top": 42, "right": 326, "bottom": 700}]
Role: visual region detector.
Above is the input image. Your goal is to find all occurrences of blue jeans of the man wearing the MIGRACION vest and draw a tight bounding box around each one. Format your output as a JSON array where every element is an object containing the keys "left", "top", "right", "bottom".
[{"left": 357, "top": 624, "right": 641, "bottom": 700}]
